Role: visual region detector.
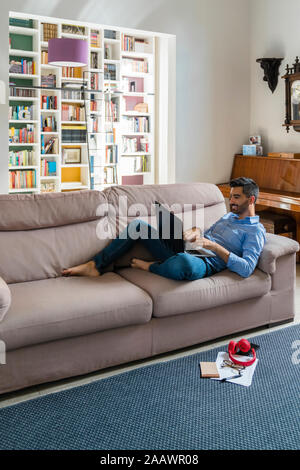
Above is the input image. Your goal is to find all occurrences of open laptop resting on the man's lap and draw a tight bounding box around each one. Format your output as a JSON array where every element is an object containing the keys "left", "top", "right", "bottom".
[{"left": 154, "top": 201, "right": 216, "bottom": 258}]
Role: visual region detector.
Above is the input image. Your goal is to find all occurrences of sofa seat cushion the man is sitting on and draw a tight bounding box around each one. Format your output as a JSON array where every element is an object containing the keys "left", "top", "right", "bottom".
[{"left": 118, "top": 268, "right": 271, "bottom": 317}]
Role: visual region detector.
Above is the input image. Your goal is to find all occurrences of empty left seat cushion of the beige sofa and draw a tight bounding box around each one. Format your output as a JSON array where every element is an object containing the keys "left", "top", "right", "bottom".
[{"left": 0, "top": 273, "right": 152, "bottom": 350}]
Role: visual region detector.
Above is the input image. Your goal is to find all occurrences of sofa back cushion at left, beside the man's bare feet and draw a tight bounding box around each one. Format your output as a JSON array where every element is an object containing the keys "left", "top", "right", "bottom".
[{"left": 0, "top": 191, "right": 110, "bottom": 284}]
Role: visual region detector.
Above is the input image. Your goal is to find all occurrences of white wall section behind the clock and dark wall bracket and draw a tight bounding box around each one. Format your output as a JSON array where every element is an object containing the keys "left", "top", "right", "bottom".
[{"left": 250, "top": 0, "right": 300, "bottom": 154}]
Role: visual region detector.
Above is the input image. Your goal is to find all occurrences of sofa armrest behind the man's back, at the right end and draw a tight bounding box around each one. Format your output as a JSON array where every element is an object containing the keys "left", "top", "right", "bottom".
[{"left": 257, "top": 233, "right": 299, "bottom": 274}]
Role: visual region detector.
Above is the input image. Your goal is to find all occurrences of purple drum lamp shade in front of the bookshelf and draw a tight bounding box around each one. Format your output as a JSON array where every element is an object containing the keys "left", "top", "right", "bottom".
[{"left": 48, "top": 38, "right": 88, "bottom": 67}]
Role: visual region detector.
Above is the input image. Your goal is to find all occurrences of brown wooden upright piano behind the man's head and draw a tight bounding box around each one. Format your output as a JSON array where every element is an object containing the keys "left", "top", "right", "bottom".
[{"left": 218, "top": 155, "right": 300, "bottom": 262}]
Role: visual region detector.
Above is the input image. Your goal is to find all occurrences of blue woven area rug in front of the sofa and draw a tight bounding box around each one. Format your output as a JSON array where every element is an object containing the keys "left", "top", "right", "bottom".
[{"left": 0, "top": 325, "right": 300, "bottom": 450}]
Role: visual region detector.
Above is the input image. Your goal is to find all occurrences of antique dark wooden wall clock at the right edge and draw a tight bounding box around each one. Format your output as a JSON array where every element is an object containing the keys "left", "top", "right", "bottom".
[{"left": 282, "top": 56, "right": 300, "bottom": 132}]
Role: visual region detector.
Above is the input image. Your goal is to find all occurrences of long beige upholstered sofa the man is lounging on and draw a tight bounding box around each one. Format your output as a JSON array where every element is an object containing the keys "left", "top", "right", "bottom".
[{"left": 0, "top": 183, "right": 298, "bottom": 394}]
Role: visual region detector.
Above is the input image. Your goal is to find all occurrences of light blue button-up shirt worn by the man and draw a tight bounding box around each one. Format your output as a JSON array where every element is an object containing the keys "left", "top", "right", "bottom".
[{"left": 204, "top": 212, "right": 266, "bottom": 277}]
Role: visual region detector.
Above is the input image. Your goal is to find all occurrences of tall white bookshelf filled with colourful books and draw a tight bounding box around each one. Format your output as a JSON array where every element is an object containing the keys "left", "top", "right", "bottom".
[{"left": 9, "top": 12, "right": 155, "bottom": 192}]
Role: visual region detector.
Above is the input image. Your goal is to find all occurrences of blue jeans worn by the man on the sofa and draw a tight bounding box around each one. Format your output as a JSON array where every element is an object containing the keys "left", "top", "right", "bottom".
[{"left": 92, "top": 219, "right": 213, "bottom": 281}]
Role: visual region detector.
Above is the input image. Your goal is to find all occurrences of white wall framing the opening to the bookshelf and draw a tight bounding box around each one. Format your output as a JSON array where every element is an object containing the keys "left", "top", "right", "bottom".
[{"left": 0, "top": 0, "right": 250, "bottom": 193}]
